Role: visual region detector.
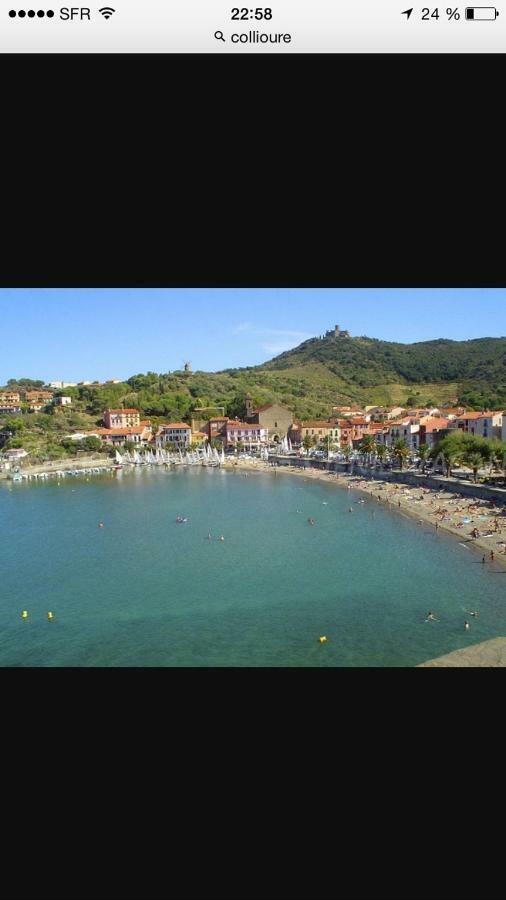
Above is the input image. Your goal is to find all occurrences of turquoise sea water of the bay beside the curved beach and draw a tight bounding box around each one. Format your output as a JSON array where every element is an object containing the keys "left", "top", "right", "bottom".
[{"left": 0, "top": 469, "right": 506, "bottom": 666}]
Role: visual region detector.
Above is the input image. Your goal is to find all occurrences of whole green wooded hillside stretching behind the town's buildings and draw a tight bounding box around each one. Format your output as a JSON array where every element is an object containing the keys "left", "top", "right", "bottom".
[{"left": 0, "top": 335, "right": 506, "bottom": 460}]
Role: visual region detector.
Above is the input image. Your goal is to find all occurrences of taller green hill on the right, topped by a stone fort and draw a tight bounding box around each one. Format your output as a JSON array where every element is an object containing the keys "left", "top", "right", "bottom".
[{"left": 216, "top": 332, "right": 506, "bottom": 415}]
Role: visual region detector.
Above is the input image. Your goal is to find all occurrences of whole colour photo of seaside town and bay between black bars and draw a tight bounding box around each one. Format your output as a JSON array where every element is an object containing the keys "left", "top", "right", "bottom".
[{"left": 0, "top": 288, "right": 506, "bottom": 668}]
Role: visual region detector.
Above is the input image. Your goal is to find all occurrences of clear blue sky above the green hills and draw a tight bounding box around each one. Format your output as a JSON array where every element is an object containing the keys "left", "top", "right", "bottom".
[{"left": 0, "top": 288, "right": 506, "bottom": 384}]
